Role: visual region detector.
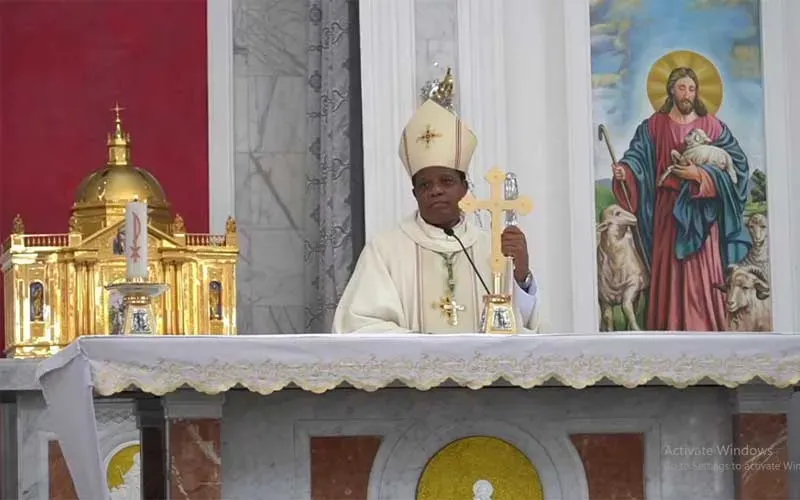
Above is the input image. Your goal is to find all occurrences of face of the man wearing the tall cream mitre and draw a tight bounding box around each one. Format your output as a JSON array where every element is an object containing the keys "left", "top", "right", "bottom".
[{"left": 413, "top": 167, "right": 467, "bottom": 228}]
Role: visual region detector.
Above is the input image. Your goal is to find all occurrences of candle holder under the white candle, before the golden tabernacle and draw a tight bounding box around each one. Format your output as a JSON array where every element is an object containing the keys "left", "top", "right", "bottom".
[{"left": 106, "top": 281, "right": 169, "bottom": 335}]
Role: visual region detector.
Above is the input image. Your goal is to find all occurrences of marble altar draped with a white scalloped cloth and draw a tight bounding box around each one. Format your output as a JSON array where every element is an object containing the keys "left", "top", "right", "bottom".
[{"left": 25, "top": 333, "right": 800, "bottom": 500}]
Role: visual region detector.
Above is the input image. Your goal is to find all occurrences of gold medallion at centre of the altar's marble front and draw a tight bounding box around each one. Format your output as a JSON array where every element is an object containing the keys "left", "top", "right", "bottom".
[{"left": 416, "top": 436, "right": 544, "bottom": 500}]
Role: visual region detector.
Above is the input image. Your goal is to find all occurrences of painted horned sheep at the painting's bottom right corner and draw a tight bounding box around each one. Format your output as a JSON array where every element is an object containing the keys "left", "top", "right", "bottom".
[{"left": 714, "top": 265, "right": 772, "bottom": 332}]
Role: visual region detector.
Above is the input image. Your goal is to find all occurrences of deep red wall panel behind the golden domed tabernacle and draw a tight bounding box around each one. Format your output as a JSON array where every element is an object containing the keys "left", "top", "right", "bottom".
[{"left": 0, "top": 0, "right": 208, "bottom": 352}]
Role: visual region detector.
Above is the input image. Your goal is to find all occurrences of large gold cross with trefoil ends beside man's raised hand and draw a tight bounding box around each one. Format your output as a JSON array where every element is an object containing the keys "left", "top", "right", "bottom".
[{"left": 458, "top": 167, "right": 533, "bottom": 275}]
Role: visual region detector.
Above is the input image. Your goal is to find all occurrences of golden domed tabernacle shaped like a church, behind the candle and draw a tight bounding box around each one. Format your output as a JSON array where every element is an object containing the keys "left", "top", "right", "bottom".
[{"left": 0, "top": 107, "right": 239, "bottom": 358}]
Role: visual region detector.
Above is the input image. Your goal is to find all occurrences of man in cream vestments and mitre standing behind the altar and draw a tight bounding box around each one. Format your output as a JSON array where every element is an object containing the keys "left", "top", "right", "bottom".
[{"left": 333, "top": 100, "right": 539, "bottom": 334}]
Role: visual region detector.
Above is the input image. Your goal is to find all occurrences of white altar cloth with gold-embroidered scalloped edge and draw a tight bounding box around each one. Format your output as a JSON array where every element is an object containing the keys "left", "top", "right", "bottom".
[{"left": 37, "top": 332, "right": 800, "bottom": 500}]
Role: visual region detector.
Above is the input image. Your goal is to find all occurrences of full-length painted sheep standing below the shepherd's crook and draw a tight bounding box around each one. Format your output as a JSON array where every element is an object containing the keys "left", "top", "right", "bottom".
[{"left": 597, "top": 204, "right": 649, "bottom": 332}]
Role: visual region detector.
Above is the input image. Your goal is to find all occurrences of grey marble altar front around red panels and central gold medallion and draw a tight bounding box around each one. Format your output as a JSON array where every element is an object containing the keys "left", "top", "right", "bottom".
[{"left": 222, "top": 387, "right": 736, "bottom": 500}]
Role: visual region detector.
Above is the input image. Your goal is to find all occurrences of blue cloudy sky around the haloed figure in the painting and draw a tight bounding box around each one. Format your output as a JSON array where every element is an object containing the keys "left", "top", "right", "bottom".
[{"left": 590, "top": 0, "right": 766, "bottom": 179}]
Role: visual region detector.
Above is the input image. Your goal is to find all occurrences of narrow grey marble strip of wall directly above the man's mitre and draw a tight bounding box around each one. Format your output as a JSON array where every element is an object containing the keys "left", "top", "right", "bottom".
[{"left": 414, "top": 0, "right": 458, "bottom": 105}]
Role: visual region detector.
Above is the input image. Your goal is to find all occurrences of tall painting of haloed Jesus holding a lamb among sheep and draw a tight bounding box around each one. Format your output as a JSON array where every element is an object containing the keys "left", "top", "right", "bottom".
[{"left": 592, "top": 0, "right": 771, "bottom": 332}]
